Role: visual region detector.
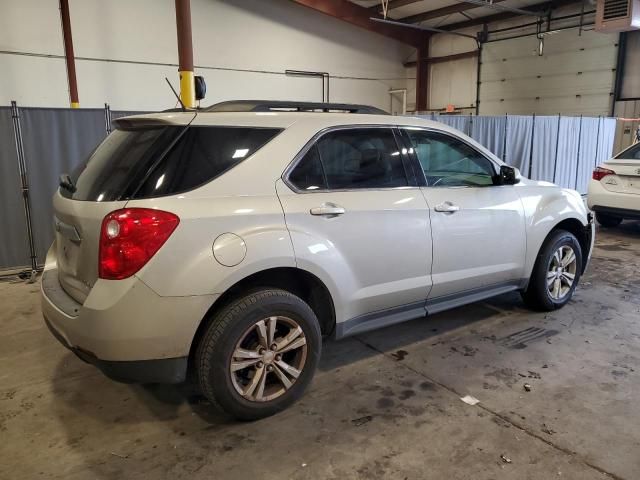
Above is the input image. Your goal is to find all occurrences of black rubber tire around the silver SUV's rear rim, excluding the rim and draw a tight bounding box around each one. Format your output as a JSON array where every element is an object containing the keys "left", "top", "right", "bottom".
[{"left": 195, "top": 289, "right": 322, "bottom": 420}]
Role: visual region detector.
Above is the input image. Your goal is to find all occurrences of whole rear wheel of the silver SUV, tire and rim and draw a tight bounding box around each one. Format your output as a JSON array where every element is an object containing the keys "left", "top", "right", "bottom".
[{"left": 196, "top": 289, "right": 321, "bottom": 420}]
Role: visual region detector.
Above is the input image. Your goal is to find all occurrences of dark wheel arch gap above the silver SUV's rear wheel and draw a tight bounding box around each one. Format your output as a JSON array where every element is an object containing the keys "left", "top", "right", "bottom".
[{"left": 189, "top": 267, "right": 336, "bottom": 364}]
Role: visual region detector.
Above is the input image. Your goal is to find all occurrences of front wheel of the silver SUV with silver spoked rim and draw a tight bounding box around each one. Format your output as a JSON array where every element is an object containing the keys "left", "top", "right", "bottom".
[{"left": 523, "top": 230, "right": 582, "bottom": 311}]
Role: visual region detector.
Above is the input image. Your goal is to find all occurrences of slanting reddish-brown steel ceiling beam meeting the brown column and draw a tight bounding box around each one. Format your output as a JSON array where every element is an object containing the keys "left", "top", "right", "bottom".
[{"left": 290, "top": 0, "right": 429, "bottom": 47}]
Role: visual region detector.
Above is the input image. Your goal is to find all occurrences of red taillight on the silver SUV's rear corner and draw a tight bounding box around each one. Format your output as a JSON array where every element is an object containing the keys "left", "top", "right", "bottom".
[{"left": 99, "top": 208, "right": 180, "bottom": 280}]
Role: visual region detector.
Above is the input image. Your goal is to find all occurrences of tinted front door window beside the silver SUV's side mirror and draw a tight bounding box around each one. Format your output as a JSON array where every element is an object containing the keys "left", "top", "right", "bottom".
[{"left": 407, "top": 130, "right": 496, "bottom": 187}]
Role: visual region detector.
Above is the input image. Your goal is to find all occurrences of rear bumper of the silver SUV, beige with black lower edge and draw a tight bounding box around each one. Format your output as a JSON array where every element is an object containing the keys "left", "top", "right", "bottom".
[{"left": 41, "top": 268, "right": 215, "bottom": 383}]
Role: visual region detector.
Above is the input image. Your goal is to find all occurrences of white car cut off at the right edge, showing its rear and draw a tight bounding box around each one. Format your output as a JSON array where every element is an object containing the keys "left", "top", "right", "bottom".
[{"left": 587, "top": 143, "right": 640, "bottom": 227}]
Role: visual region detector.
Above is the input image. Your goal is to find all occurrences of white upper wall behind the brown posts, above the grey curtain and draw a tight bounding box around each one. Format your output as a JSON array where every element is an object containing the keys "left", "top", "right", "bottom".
[{"left": 0, "top": 0, "right": 415, "bottom": 110}]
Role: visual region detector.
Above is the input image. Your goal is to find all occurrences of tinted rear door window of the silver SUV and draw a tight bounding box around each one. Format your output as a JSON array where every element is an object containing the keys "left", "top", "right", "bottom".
[{"left": 289, "top": 128, "right": 409, "bottom": 190}]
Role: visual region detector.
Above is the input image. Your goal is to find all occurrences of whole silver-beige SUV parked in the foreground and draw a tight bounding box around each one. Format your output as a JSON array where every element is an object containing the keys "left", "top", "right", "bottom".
[{"left": 42, "top": 101, "right": 594, "bottom": 419}]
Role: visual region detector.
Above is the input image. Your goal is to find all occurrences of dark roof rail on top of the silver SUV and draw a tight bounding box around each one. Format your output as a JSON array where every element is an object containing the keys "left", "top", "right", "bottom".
[{"left": 201, "top": 100, "right": 389, "bottom": 115}]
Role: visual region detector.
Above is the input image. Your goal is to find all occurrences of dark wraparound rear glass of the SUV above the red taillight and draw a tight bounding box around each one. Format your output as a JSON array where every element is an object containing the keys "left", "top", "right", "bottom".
[{"left": 60, "top": 126, "right": 281, "bottom": 202}]
